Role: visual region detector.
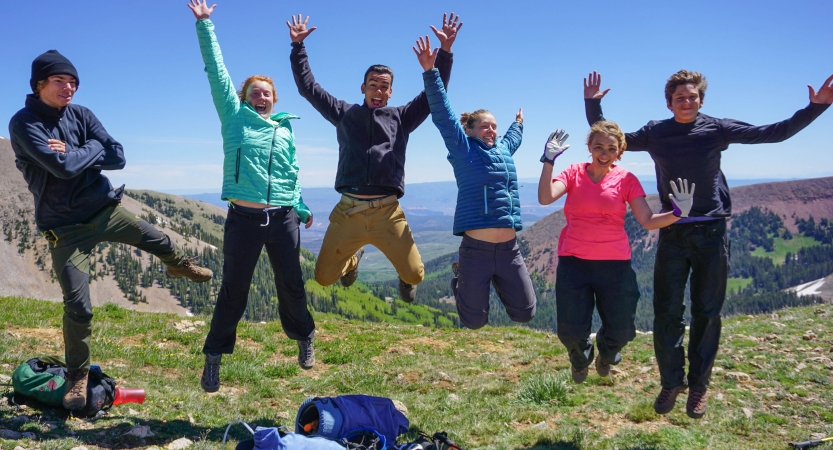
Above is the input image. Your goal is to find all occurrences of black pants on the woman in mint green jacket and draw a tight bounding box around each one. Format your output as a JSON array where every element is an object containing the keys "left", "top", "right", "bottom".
[{"left": 203, "top": 206, "right": 315, "bottom": 354}]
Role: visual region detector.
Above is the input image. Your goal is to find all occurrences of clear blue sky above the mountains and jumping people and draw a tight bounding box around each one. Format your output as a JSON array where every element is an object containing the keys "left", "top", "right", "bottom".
[{"left": 0, "top": 0, "right": 833, "bottom": 192}]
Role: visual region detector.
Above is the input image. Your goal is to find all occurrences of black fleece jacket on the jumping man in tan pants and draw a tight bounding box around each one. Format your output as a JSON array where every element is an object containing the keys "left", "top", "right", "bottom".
[{"left": 289, "top": 43, "right": 453, "bottom": 197}]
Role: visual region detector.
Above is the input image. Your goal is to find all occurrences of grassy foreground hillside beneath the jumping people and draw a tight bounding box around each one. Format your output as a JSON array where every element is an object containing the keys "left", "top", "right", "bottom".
[{"left": 0, "top": 298, "right": 833, "bottom": 450}]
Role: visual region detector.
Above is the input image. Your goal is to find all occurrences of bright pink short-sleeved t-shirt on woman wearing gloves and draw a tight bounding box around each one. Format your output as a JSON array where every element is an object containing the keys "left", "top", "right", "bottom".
[{"left": 553, "top": 163, "right": 645, "bottom": 260}]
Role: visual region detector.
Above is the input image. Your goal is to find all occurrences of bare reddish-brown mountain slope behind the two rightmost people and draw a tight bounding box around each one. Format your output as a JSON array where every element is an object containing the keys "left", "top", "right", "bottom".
[{"left": 521, "top": 177, "right": 833, "bottom": 281}]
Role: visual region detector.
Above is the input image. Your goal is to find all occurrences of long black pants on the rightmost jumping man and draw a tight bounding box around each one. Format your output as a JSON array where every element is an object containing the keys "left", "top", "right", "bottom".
[{"left": 654, "top": 219, "right": 730, "bottom": 391}]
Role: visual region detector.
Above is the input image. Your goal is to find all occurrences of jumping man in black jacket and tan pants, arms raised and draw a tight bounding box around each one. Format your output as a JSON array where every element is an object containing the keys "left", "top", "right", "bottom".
[{"left": 286, "top": 13, "right": 463, "bottom": 302}]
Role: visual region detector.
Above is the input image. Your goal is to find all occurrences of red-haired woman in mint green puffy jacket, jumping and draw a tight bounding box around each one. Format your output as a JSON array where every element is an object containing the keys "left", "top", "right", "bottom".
[{"left": 188, "top": 0, "right": 315, "bottom": 392}]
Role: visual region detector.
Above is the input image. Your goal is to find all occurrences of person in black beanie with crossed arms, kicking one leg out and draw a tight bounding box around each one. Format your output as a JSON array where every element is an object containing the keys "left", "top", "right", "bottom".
[{"left": 9, "top": 50, "right": 212, "bottom": 410}]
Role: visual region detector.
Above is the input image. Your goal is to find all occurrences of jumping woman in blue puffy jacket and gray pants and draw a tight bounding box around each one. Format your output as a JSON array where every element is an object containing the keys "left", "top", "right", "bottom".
[{"left": 414, "top": 36, "right": 537, "bottom": 329}]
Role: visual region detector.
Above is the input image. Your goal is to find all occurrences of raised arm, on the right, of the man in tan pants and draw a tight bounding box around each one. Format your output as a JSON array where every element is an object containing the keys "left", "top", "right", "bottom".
[{"left": 400, "top": 13, "right": 463, "bottom": 133}]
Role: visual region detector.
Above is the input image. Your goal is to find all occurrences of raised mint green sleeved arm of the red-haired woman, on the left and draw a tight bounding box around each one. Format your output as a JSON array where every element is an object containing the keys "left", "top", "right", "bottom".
[{"left": 188, "top": 0, "right": 240, "bottom": 122}]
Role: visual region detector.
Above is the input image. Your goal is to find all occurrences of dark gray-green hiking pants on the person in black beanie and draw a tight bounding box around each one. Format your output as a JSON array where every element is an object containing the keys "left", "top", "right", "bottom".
[{"left": 43, "top": 204, "right": 183, "bottom": 370}]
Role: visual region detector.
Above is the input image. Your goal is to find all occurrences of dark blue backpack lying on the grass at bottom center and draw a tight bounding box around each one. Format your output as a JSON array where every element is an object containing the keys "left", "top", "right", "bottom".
[{"left": 295, "top": 395, "right": 409, "bottom": 450}]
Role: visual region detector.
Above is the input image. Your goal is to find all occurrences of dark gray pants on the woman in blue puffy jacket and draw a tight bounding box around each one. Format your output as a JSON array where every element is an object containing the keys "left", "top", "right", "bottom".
[{"left": 451, "top": 236, "right": 538, "bottom": 329}]
